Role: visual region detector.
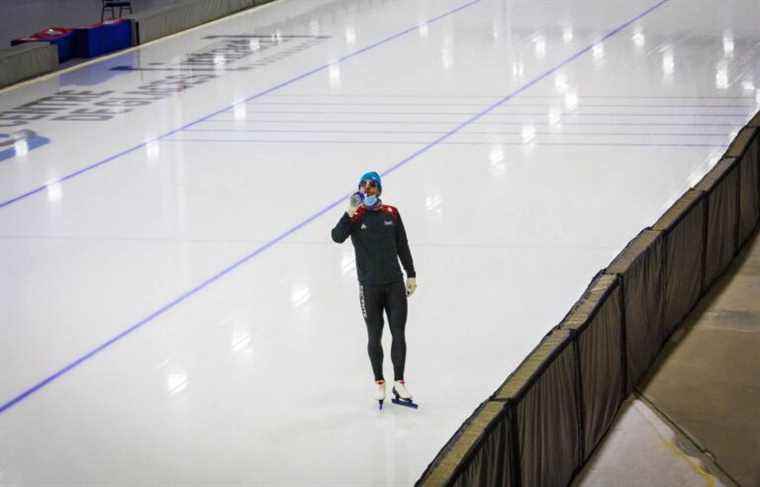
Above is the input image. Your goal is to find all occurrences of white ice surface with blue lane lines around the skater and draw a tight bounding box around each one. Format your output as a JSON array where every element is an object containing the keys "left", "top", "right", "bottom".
[{"left": 0, "top": 0, "right": 760, "bottom": 487}]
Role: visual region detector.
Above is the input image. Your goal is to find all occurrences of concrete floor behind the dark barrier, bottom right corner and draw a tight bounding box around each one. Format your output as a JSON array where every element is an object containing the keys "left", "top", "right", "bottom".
[{"left": 575, "top": 234, "right": 760, "bottom": 487}]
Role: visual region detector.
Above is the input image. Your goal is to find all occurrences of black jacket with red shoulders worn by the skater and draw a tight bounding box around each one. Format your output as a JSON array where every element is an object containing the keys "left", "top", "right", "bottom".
[{"left": 332, "top": 205, "right": 416, "bottom": 286}]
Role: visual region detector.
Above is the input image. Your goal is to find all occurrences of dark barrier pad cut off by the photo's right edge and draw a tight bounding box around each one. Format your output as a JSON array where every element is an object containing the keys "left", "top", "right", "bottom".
[{"left": 726, "top": 127, "right": 760, "bottom": 245}]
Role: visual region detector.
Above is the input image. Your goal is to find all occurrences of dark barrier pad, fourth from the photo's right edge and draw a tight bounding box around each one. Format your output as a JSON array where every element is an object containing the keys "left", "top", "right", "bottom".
[{"left": 606, "top": 228, "right": 667, "bottom": 395}]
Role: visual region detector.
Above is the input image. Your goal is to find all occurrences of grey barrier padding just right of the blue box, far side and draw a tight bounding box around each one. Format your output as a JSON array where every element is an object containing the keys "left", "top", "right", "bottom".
[{"left": 127, "top": 0, "right": 262, "bottom": 45}]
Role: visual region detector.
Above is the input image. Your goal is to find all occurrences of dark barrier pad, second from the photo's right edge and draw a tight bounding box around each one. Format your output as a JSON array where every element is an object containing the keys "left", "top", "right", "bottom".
[{"left": 694, "top": 157, "right": 739, "bottom": 289}]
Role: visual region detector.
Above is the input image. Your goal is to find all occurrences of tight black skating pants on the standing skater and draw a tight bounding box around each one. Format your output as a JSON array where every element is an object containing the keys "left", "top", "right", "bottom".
[{"left": 359, "top": 282, "right": 407, "bottom": 380}]
